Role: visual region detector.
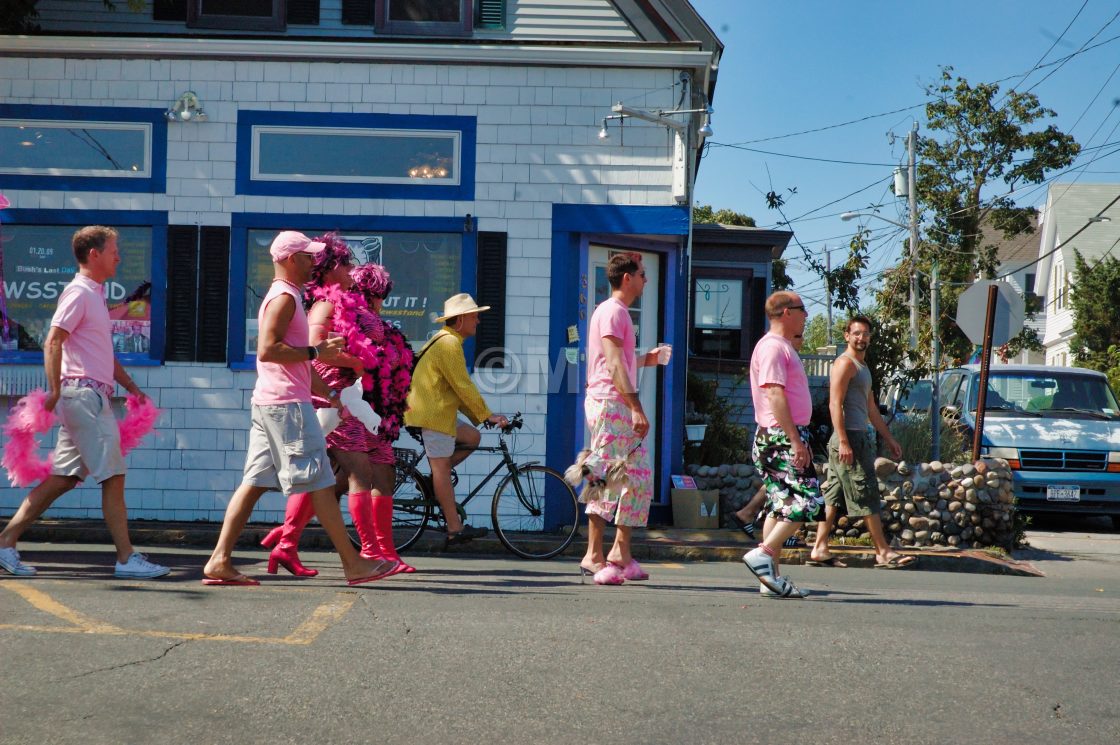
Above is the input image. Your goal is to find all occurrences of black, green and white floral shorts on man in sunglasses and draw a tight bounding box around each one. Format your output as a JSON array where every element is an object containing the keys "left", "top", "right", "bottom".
[{"left": 752, "top": 427, "right": 824, "bottom": 522}]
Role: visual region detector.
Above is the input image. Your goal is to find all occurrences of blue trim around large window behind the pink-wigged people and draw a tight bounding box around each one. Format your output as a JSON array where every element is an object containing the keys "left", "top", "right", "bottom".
[{"left": 226, "top": 212, "right": 478, "bottom": 371}]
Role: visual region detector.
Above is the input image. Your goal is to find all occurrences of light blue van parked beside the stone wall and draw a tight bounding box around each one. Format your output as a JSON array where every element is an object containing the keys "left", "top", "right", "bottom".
[{"left": 941, "top": 365, "right": 1120, "bottom": 529}]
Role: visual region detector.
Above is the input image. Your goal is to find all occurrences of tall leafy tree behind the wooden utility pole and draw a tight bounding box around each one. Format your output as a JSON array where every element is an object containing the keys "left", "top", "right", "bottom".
[{"left": 877, "top": 67, "right": 1081, "bottom": 366}]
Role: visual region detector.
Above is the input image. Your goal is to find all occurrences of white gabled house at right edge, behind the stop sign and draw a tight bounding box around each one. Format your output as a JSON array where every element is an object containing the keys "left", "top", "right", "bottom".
[{"left": 1034, "top": 184, "right": 1120, "bottom": 366}]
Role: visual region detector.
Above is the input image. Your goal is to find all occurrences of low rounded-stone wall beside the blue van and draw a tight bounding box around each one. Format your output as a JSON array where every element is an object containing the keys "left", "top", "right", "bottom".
[{"left": 687, "top": 458, "right": 1015, "bottom": 549}]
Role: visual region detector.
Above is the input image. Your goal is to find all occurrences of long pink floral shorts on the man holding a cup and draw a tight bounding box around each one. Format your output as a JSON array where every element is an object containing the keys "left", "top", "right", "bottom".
[{"left": 584, "top": 397, "right": 653, "bottom": 528}]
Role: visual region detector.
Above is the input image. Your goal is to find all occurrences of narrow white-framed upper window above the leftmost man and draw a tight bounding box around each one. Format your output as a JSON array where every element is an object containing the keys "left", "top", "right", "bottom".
[{"left": 0, "top": 119, "right": 151, "bottom": 178}]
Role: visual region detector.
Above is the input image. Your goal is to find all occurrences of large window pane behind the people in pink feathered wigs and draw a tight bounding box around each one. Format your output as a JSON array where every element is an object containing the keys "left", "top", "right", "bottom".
[{"left": 245, "top": 229, "right": 463, "bottom": 354}]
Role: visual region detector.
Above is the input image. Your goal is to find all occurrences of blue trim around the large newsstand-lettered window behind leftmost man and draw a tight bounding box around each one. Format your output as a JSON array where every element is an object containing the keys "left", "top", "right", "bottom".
[{"left": 0, "top": 209, "right": 167, "bottom": 366}]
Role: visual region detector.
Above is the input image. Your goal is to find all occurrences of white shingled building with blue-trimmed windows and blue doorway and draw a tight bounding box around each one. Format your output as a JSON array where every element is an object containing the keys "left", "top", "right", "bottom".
[{"left": 0, "top": 0, "right": 722, "bottom": 520}]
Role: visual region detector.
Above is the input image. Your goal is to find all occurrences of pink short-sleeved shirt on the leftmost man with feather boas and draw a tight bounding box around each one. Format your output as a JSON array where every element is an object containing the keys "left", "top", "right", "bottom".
[{"left": 50, "top": 274, "right": 114, "bottom": 385}]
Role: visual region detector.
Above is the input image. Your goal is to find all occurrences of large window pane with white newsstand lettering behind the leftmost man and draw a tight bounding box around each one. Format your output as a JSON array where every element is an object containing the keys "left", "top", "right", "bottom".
[{"left": 0, "top": 225, "right": 151, "bottom": 354}]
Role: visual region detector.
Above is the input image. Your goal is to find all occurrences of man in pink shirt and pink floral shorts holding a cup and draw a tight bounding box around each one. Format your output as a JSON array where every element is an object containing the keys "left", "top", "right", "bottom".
[{"left": 577, "top": 252, "right": 672, "bottom": 585}]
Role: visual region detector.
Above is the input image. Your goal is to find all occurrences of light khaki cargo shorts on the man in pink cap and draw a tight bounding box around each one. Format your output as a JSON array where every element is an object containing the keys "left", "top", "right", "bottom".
[{"left": 242, "top": 403, "right": 335, "bottom": 495}]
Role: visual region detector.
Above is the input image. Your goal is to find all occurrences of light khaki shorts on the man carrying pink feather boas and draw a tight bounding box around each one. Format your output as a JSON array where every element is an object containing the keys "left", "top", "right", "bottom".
[{"left": 50, "top": 387, "right": 128, "bottom": 484}]
